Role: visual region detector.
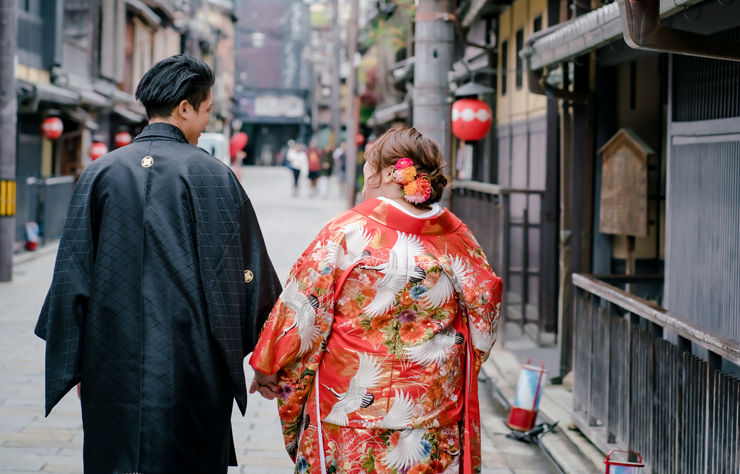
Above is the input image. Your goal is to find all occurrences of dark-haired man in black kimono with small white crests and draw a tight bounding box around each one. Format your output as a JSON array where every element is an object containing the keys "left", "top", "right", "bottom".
[{"left": 36, "top": 55, "right": 281, "bottom": 474}]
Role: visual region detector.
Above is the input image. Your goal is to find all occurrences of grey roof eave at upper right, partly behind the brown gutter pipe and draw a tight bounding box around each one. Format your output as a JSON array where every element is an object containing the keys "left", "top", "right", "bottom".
[{"left": 522, "top": 0, "right": 697, "bottom": 70}]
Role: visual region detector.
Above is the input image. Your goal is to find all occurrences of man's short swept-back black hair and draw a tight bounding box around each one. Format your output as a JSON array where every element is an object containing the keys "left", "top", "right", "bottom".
[{"left": 136, "top": 54, "right": 216, "bottom": 119}]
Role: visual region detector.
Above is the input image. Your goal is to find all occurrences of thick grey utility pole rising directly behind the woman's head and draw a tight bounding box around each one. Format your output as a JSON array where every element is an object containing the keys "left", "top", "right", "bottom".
[{"left": 413, "top": 0, "right": 455, "bottom": 180}]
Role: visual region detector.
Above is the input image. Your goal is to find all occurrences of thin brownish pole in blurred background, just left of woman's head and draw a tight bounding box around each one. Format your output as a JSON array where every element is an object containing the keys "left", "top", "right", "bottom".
[{"left": 344, "top": 0, "right": 360, "bottom": 207}]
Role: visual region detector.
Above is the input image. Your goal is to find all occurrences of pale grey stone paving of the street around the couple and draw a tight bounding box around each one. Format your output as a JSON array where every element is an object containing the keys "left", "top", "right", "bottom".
[{"left": 0, "top": 168, "right": 557, "bottom": 474}]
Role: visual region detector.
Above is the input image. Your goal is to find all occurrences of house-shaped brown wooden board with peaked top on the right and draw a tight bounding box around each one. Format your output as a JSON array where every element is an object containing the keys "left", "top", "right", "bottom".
[{"left": 599, "top": 128, "right": 654, "bottom": 237}]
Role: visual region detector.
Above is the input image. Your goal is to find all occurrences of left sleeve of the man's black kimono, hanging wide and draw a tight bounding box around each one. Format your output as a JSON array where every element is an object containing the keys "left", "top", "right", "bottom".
[{"left": 34, "top": 170, "right": 95, "bottom": 416}]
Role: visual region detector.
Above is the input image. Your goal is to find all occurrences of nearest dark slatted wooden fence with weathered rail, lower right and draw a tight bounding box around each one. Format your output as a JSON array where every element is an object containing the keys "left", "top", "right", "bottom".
[{"left": 573, "top": 274, "right": 740, "bottom": 474}]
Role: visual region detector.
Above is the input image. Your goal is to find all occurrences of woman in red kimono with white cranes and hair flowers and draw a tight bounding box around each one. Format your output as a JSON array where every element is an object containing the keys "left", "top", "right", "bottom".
[{"left": 250, "top": 129, "right": 501, "bottom": 474}]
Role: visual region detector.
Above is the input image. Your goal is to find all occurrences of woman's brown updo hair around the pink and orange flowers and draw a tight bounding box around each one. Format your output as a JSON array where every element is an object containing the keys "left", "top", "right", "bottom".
[{"left": 365, "top": 128, "right": 449, "bottom": 207}]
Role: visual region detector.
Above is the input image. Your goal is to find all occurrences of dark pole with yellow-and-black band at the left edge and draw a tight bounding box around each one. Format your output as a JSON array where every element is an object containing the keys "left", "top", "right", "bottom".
[{"left": 0, "top": 0, "right": 18, "bottom": 281}]
